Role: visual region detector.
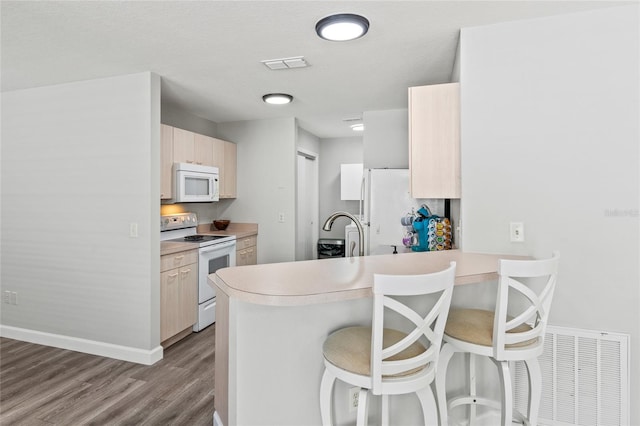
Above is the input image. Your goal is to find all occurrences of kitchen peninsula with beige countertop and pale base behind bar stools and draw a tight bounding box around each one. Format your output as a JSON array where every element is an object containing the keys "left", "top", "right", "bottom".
[{"left": 209, "top": 250, "right": 519, "bottom": 426}]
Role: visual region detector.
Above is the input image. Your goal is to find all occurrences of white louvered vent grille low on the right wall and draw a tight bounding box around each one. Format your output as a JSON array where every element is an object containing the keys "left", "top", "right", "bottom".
[{"left": 512, "top": 326, "right": 630, "bottom": 426}]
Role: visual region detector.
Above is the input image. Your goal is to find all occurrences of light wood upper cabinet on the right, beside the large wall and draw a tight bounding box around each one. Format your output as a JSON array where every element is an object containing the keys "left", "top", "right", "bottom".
[{"left": 409, "top": 83, "right": 460, "bottom": 198}]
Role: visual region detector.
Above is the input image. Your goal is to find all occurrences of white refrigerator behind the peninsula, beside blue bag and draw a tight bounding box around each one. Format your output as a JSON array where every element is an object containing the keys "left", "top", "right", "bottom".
[{"left": 345, "top": 169, "right": 444, "bottom": 256}]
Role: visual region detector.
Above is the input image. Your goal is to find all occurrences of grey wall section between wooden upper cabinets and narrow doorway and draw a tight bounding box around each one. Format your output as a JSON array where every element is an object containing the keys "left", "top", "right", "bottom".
[{"left": 218, "top": 118, "right": 297, "bottom": 263}]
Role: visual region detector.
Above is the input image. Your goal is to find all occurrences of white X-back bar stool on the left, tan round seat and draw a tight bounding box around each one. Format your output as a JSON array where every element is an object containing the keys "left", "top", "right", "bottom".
[{"left": 320, "top": 262, "right": 455, "bottom": 425}]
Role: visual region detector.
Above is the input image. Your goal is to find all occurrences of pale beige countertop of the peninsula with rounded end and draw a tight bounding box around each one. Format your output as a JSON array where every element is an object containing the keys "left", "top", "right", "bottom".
[{"left": 209, "top": 250, "right": 529, "bottom": 306}]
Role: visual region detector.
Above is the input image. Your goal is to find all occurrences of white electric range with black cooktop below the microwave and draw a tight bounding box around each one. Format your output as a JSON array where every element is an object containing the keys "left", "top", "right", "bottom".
[{"left": 160, "top": 213, "right": 236, "bottom": 331}]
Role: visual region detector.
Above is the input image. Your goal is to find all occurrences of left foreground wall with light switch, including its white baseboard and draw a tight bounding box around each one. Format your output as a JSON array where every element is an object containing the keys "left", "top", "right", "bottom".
[{"left": 0, "top": 73, "right": 162, "bottom": 362}]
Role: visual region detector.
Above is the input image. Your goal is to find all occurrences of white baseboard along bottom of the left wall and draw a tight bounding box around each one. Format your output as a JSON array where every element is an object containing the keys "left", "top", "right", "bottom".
[{"left": 0, "top": 324, "right": 163, "bottom": 365}]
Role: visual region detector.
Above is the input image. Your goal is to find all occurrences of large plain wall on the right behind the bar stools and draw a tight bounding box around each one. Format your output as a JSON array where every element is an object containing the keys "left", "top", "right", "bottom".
[{"left": 460, "top": 5, "right": 640, "bottom": 424}]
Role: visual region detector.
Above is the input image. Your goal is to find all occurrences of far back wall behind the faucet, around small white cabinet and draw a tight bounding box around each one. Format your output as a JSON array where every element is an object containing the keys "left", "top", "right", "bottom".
[{"left": 318, "top": 136, "right": 363, "bottom": 238}]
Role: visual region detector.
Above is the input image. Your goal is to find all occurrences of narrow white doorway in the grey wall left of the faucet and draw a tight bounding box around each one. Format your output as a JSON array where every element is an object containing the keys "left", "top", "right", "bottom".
[{"left": 296, "top": 148, "right": 319, "bottom": 260}]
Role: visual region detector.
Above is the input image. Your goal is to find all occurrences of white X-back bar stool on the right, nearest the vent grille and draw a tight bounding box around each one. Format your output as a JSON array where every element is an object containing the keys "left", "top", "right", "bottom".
[{"left": 436, "top": 252, "right": 559, "bottom": 426}]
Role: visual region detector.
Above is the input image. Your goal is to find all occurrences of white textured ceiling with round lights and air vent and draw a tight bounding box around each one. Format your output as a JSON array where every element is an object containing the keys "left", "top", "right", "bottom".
[{"left": 1, "top": 0, "right": 637, "bottom": 138}]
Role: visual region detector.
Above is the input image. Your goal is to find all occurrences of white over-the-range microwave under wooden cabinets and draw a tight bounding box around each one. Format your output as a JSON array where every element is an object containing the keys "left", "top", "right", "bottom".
[{"left": 172, "top": 163, "right": 220, "bottom": 203}]
